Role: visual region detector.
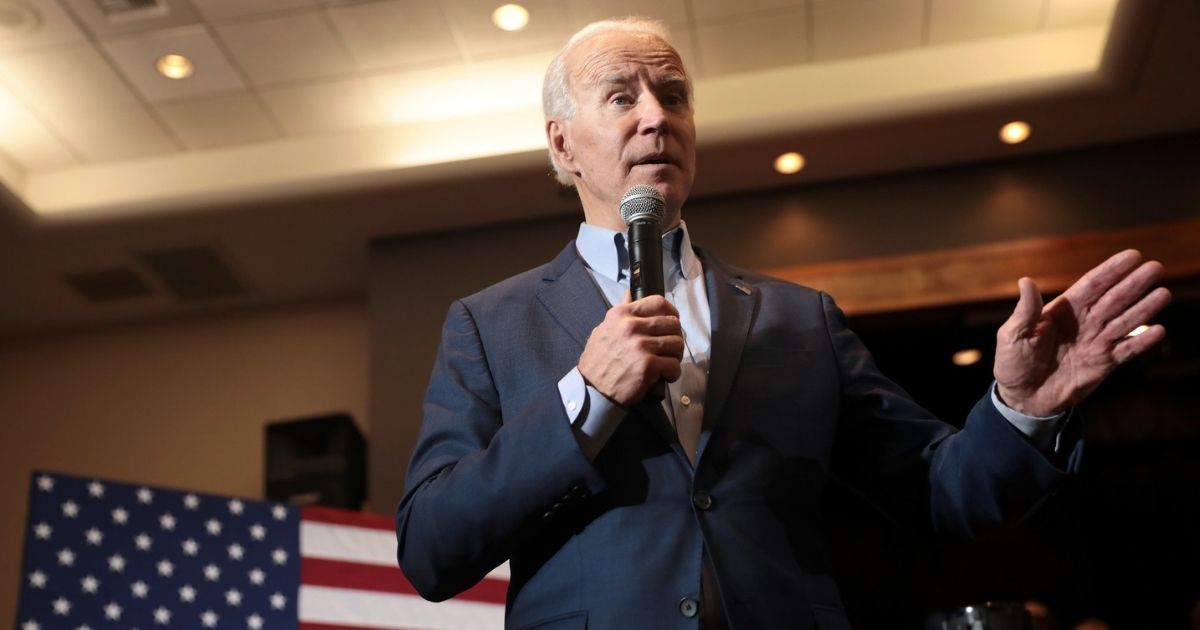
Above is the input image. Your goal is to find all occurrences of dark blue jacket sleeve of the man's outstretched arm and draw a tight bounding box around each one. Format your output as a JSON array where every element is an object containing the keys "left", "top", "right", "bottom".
[{"left": 822, "top": 294, "right": 1081, "bottom": 538}]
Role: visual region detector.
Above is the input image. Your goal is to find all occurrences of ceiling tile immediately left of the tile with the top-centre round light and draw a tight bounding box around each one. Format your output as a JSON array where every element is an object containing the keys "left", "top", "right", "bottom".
[{"left": 328, "top": 0, "right": 462, "bottom": 68}]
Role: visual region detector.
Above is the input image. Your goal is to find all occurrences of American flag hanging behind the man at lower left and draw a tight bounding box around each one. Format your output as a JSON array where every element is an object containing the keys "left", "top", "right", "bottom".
[{"left": 17, "top": 472, "right": 508, "bottom": 630}]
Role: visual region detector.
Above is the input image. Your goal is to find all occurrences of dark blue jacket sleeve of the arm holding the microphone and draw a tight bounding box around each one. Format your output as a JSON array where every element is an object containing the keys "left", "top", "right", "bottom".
[{"left": 396, "top": 301, "right": 604, "bottom": 600}]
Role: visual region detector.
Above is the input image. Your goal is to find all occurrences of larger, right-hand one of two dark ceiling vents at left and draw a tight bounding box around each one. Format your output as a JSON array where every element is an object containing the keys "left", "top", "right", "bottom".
[{"left": 137, "top": 247, "right": 250, "bottom": 302}]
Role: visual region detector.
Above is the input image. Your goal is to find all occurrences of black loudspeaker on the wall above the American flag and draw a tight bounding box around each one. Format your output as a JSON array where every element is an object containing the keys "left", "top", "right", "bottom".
[{"left": 264, "top": 414, "right": 367, "bottom": 510}]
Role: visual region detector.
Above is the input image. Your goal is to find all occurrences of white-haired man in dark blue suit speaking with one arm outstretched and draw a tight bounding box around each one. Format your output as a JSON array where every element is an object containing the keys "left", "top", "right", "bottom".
[{"left": 396, "top": 20, "right": 1169, "bottom": 630}]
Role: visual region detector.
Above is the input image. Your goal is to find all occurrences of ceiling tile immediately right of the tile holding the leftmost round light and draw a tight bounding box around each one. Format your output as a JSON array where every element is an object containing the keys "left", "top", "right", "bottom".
[{"left": 215, "top": 11, "right": 354, "bottom": 85}]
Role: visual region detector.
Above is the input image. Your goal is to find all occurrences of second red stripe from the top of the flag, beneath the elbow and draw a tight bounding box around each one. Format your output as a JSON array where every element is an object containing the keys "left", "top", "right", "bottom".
[{"left": 300, "top": 558, "right": 509, "bottom": 605}]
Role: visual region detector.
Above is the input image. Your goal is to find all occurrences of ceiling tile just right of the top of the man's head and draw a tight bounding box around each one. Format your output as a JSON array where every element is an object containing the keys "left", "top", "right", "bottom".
[{"left": 696, "top": 11, "right": 808, "bottom": 77}]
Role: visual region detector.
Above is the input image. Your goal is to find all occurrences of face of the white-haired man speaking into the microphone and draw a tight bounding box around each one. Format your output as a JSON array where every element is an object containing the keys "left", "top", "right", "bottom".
[{"left": 551, "top": 32, "right": 696, "bottom": 229}]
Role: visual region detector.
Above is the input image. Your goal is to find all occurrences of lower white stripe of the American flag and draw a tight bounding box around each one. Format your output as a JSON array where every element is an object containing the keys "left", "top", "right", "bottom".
[{"left": 299, "top": 586, "right": 504, "bottom": 630}]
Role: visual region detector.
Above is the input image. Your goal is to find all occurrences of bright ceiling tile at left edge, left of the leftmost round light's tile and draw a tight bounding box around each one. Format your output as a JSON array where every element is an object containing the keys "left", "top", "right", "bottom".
[{"left": 0, "top": 44, "right": 138, "bottom": 114}]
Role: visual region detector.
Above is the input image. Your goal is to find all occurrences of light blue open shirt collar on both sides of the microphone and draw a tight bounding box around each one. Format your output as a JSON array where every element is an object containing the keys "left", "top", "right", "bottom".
[{"left": 575, "top": 221, "right": 701, "bottom": 282}]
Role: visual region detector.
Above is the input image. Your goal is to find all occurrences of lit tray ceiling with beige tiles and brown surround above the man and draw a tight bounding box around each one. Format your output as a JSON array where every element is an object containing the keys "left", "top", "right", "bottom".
[{"left": 0, "top": 0, "right": 1200, "bottom": 337}]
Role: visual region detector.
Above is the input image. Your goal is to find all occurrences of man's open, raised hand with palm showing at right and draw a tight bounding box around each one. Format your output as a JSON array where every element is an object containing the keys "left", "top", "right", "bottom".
[{"left": 995, "top": 250, "right": 1171, "bottom": 416}]
